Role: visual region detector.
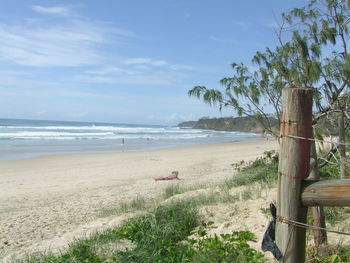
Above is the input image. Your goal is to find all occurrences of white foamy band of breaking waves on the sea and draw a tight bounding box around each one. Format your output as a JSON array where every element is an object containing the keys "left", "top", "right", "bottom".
[{"left": 0, "top": 125, "right": 256, "bottom": 140}]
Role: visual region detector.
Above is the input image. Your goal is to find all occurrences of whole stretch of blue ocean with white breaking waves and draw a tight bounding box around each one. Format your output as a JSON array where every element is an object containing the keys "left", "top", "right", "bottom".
[{"left": 0, "top": 119, "right": 261, "bottom": 160}]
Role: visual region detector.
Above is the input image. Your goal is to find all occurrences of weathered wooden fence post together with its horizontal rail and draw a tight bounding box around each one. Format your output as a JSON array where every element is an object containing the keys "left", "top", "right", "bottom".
[{"left": 276, "top": 88, "right": 350, "bottom": 263}]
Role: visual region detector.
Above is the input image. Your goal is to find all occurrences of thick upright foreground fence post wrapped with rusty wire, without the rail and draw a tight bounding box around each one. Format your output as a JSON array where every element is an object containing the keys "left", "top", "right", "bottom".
[{"left": 276, "top": 88, "right": 313, "bottom": 263}]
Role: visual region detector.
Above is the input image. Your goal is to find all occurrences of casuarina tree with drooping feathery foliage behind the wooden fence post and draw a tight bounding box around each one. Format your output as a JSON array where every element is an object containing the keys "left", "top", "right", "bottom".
[{"left": 188, "top": 0, "right": 350, "bottom": 248}]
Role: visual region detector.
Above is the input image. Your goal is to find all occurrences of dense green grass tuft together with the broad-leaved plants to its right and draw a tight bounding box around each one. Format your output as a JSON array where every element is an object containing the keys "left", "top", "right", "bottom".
[{"left": 111, "top": 201, "right": 263, "bottom": 263}]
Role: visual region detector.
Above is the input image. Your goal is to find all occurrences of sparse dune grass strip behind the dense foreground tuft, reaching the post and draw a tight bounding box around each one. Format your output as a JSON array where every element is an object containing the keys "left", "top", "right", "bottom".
[{"left": 99, "top": 151, "right": 278, "bottom": 222}]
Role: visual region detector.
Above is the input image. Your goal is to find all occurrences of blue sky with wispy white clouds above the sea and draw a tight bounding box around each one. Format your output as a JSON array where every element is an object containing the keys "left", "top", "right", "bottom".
[{"left": 0, "top": 0, "right": 307, "bottom": 125}]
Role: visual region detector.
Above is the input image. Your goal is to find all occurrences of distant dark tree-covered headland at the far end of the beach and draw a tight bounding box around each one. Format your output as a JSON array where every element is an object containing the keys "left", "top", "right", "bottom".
[{"left": 178, "top": 117, "right": 278, "bottom": 132}]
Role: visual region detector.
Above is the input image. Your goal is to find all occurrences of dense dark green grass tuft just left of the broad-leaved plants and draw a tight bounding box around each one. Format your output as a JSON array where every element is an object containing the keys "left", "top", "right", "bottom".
[{"left": 118, "top": 202, "right": 199, "bottom": 263}]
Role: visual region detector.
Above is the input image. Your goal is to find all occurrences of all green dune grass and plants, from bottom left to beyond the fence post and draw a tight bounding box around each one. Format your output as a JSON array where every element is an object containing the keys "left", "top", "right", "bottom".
[{"left": 15, "top": 148, "right": 350, "bottom": 263}]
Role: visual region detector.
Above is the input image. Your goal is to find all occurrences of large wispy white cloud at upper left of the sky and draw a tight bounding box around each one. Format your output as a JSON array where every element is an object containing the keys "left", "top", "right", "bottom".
[{"left": 0, "top": 11, "right": 134, "bottom": 67}]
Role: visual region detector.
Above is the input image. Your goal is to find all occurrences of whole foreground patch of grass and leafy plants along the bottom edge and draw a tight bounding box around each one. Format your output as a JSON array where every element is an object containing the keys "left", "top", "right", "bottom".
[{"left": 17, "top": 202, "right": 262, "bottom": 263}]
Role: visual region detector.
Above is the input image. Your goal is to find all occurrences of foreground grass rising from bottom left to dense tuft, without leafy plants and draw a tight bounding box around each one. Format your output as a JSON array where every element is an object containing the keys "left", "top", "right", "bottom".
[{"left": 17, "top": 202, "right": 199, "bottom": 263}]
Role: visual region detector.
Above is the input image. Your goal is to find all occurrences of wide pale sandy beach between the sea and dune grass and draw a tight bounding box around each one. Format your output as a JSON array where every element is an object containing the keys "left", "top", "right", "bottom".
[{"left": 0, "top": 139, "right": 278, "bottom": 262}]
